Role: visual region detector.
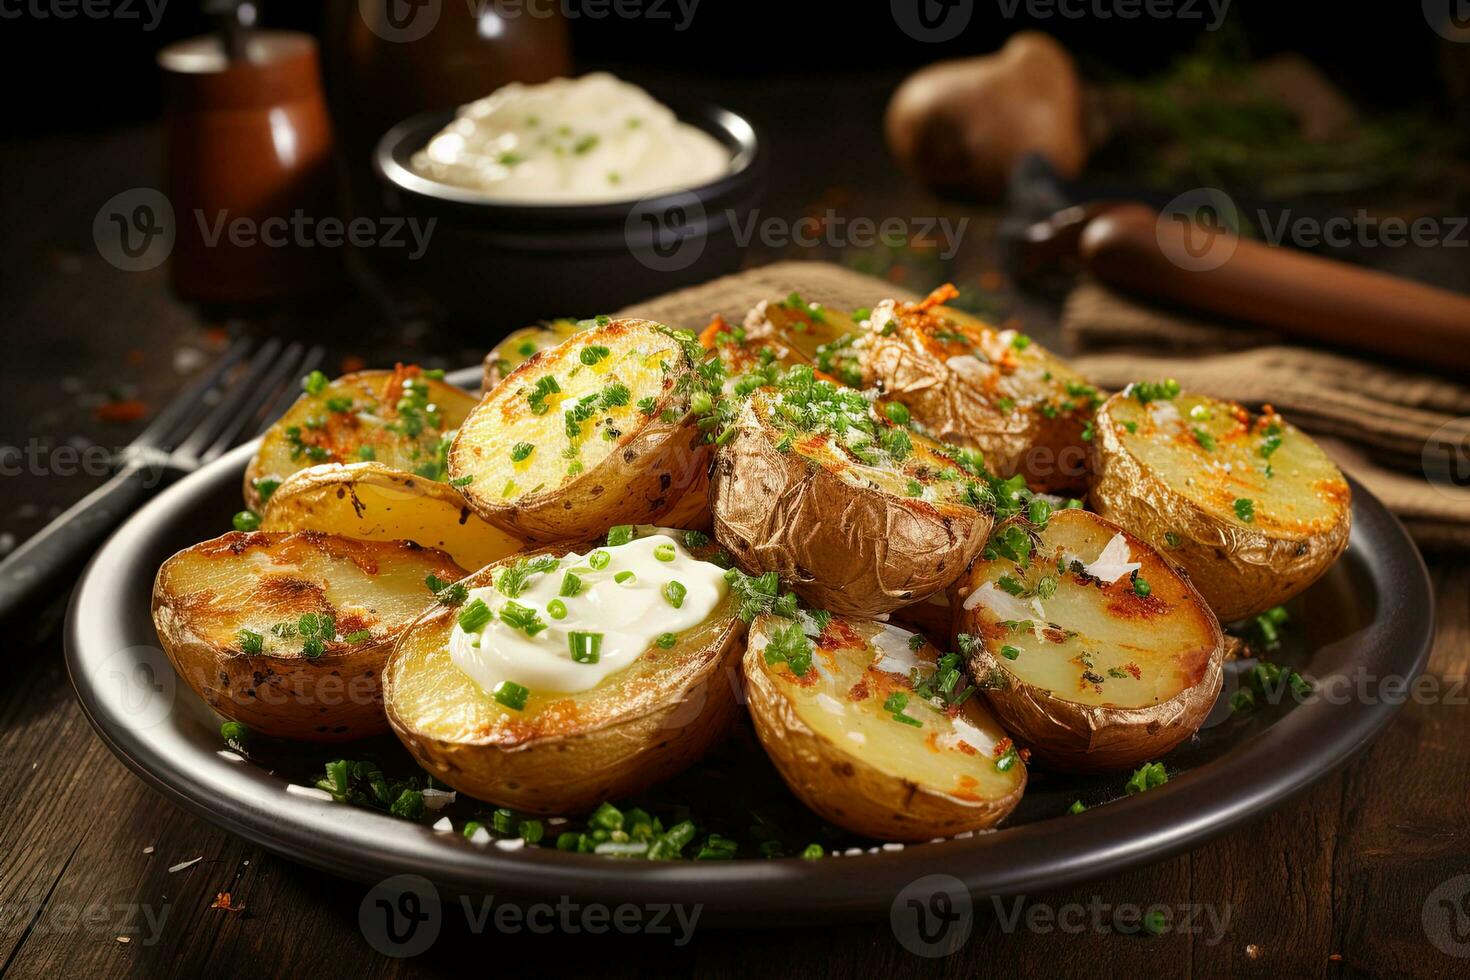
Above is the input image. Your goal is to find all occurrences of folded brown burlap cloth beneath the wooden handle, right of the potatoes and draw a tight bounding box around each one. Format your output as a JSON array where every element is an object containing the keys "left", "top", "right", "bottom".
[{"left": 1061, "top": 282, "right": 1470, "bottom": 550}]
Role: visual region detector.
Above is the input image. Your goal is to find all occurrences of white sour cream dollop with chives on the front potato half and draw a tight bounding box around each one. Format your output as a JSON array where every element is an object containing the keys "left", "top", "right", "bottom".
[{"left": 450, "top": 533, "right": 729, "bottom": 693}]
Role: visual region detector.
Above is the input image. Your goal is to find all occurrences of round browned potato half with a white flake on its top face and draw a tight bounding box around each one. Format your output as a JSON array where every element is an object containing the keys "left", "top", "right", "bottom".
[{"left": 953, "top": 510, "right": 1225, "bottom": 771}]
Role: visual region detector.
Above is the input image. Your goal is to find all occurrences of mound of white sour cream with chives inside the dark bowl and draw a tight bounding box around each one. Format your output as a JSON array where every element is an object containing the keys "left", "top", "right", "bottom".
[{"left": 412, "top": 72, "right": 731, "bottom": 204}]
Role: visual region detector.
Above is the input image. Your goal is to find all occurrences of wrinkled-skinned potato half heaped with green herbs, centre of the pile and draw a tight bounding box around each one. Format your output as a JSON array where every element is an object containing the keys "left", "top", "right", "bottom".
[{"left": 710, "top": 366, "right": 992, "bottom": 617}]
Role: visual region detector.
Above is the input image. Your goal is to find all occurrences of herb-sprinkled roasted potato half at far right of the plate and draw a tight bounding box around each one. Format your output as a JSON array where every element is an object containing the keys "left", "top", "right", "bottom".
[{"left": 1091, "top": 382, "right": 1352, "bottom": 623}]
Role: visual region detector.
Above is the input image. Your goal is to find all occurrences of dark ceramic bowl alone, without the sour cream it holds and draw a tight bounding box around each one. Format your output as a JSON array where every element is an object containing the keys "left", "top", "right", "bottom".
[{"left": 373, "top": 103, "right": 764, "bottom": 338}]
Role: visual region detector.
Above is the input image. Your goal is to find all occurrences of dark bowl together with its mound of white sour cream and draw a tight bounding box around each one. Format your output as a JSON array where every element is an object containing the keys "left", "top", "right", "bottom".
[{"left": 373, "top": 72, "right": 764, "bottom": 332}]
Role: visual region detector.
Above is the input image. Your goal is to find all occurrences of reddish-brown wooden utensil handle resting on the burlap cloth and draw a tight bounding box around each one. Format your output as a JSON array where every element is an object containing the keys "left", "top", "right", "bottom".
[{"left": 1080, "top": 204, "right": 1470, "bottom": 370}]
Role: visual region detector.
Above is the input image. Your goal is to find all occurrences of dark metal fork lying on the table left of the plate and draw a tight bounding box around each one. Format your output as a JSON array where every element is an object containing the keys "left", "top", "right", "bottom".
[{"left": 0, "top": 338, "right": 322, "bottom": 621}]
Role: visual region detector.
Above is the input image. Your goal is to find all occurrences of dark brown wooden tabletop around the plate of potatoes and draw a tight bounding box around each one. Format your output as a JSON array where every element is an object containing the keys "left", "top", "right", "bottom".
[{"left": 0, "top": 72, "right": 1470, "bottom": 977}]
